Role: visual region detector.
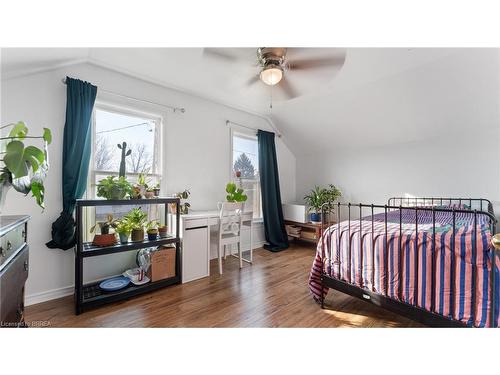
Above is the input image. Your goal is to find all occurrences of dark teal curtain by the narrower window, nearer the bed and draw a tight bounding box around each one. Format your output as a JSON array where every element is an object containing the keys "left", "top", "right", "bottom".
[{"left": 257, "top": 130, "right": 288, "bottom": 252}]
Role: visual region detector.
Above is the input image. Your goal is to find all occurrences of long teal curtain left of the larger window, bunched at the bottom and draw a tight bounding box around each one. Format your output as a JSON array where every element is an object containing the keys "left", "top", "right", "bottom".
[{"left": 46, "top": 77, "right": 97, "bottom": 250}]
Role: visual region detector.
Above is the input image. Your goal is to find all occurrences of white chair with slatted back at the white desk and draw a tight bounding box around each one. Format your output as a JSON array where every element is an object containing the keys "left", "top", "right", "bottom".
[{"left": 217, "top": 202, "right": 252, "bottom": 275}]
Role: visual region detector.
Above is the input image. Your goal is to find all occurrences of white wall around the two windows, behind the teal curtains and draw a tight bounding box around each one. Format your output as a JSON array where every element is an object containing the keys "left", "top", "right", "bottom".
[{"left": 1, "top": 64, "right": 296, "bottom": 304}]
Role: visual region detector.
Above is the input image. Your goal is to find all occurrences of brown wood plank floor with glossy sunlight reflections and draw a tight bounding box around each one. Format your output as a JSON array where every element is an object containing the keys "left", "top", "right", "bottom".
[{"left": 26, "top": 245, "right": 421, "bottom": 327}]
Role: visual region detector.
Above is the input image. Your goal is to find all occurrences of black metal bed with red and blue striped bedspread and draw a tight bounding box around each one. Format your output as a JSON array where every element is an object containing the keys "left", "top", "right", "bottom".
[{"left": 309, "top": 198, "right": 500, "bottom": 327}]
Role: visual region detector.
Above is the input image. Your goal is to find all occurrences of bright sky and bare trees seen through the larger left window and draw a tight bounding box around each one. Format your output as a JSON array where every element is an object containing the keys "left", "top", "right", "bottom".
[{"left": 94, "top": 109, "right": 156, "bottom": 173}]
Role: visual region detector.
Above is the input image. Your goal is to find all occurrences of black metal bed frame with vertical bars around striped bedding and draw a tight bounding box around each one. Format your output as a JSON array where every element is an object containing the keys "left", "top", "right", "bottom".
[{"left": 320, "top": 197, "right": 498, "bottom": 327}]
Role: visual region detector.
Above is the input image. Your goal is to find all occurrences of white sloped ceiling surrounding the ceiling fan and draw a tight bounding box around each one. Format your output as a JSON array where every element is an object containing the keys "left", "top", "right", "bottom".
[{"left": 2, "top": 48, "right": 492, "bottom": 154}]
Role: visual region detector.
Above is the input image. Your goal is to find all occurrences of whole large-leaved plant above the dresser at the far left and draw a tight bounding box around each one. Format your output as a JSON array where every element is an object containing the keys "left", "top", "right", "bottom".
[{"left": 0, "top": 121, "right": 52, "bottom": 213}]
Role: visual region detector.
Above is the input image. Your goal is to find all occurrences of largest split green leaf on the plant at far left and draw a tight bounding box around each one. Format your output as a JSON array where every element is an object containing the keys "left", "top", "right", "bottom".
[{"left": 4, "top": 141, "right": 45, "bottom": 178}]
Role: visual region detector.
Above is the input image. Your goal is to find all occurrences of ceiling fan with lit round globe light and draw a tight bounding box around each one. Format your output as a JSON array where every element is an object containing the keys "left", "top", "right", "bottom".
[{"left": 203, "top": 47, "right": 345, "bottom": 99}]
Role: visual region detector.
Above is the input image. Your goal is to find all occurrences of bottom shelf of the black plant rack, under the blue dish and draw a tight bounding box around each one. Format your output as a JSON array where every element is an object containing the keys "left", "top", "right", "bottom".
[{"left": 82, "top": 276, "right": 181, "bottom": 307}]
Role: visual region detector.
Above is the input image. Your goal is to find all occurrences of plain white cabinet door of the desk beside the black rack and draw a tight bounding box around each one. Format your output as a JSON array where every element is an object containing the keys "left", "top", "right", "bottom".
[{"left": 182, "top": 227, "right": 209, "bottom": 283}]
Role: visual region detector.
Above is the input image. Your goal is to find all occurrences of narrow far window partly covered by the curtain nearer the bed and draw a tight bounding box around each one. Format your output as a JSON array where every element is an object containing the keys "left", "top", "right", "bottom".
[{"left": 231, "top": 131, "right": 262, "bottom": 220}]
